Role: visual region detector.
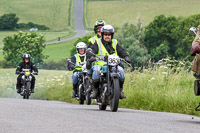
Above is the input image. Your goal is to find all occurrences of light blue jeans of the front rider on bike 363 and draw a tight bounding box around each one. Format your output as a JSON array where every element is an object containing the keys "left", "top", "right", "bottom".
[{"left": 92, "top": 65, "right": 124, "bottom": 81}]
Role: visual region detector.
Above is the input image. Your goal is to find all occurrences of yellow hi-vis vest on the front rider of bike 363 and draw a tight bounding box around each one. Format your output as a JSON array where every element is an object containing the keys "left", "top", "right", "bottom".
[{"left": 95, "top": 38, "right": 117, "bottom": 66}]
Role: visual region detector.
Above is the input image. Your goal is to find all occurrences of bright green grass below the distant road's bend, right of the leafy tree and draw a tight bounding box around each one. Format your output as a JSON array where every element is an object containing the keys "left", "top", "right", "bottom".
[{"left": 44, "top": 39, "right": 76, "bottom": 61}]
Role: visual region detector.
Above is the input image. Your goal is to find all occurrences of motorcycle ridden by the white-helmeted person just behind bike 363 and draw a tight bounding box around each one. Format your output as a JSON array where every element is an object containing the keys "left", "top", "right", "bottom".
[{"left": 68, "top": 59, "right": 91, "bottom": 105}]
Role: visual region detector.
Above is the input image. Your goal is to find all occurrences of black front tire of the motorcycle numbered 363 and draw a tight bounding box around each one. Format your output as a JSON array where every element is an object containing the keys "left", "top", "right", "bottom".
[{"left": 110, "top": 78, "right": 120, "bottom": 112}]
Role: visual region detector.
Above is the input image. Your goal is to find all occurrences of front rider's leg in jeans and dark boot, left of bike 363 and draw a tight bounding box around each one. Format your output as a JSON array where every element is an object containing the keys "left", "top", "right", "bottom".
[{"left": 90, "top": 65, "right": 101, "bottom": 98}]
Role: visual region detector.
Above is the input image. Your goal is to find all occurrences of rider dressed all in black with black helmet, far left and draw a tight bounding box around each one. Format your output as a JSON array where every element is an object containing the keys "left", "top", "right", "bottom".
[{"left": 16, "top": 54, "right": 38, "bottom": 93}]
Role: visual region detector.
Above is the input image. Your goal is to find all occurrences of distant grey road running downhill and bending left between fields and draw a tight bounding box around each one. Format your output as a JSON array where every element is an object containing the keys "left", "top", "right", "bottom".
[{"left": 45, "top": 0, "right": 90, "bottom": 45}]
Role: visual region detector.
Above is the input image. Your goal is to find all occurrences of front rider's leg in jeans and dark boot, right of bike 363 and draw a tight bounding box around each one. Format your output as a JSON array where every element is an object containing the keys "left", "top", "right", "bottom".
[{"left": 118, "top": 66, "right": 126, "bottom": 99}]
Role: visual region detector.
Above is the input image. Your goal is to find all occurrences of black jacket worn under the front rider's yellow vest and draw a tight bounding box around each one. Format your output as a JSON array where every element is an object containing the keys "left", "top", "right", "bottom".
[{"left": 86, "top": 41, "right": 128, "bottom": 69}]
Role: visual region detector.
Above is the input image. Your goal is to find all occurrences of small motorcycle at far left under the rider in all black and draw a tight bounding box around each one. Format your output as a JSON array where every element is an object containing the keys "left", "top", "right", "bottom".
[{"left": 20, "top": 69, "right": 37, "bottom": 99}]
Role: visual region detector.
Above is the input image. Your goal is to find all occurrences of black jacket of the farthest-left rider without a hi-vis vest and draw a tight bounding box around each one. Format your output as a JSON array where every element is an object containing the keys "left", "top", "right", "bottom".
[{"left": 16, "top": 61, "right": 38, "bottom": 74}]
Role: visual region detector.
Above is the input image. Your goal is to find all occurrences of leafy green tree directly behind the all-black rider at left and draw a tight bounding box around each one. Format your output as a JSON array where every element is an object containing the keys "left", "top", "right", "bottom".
[{"left": 3, "top": 31, "right": 47, "bottom": 67}]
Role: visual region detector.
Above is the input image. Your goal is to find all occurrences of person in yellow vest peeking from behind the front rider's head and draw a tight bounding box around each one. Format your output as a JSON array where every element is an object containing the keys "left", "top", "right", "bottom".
[{"left": 88, "top": 20, "right": 106, "bottom": 48}]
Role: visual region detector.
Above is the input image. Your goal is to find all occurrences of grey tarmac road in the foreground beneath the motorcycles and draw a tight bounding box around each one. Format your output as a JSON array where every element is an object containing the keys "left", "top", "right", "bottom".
[{"left": 0, "top": 98, "right": 200, "bottom": 133}]
